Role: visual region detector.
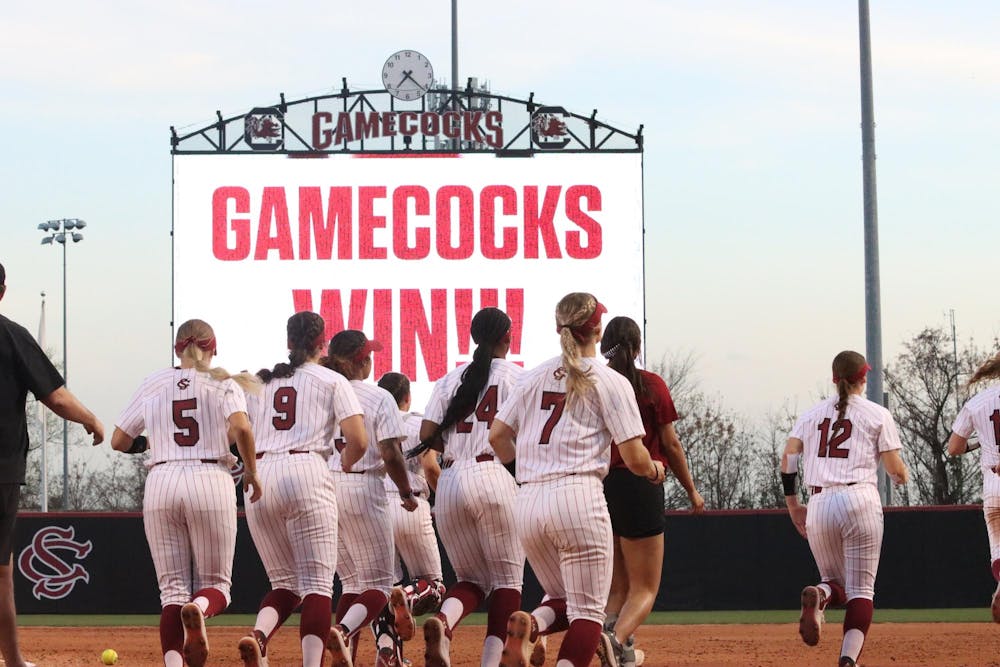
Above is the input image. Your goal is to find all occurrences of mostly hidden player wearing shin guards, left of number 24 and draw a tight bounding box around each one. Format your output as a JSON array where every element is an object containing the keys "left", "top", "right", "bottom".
[{"left": 378, "top": 373, "right": 445, "bottom": 616}]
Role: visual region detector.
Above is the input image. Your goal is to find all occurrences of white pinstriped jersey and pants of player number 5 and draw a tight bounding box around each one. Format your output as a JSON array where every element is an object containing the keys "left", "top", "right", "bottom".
[{"left": 116, "top": 368, "right": 247, "bottom": 607}]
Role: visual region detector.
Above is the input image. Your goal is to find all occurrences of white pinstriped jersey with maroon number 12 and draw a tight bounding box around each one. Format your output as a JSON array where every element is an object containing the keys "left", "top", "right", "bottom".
[{"left": 789, "top": 394, "right": 903, "bottom": 486}]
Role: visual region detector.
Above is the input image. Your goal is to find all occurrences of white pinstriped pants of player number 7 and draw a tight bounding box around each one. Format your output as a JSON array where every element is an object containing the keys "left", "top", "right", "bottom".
[{"left": 517, "top": 475, "right": 613, "bottom": 624}]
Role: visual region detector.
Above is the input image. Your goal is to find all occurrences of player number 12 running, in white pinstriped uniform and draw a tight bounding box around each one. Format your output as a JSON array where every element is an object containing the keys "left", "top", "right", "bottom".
[{"left": 781, "top": 351, "right": 909, "bottom": 667}]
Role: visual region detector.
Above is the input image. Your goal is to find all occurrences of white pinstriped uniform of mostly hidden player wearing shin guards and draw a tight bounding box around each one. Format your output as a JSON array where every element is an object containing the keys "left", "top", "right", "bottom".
[{"left": 385, "top": 412, "right": 442, "bottom": 581}]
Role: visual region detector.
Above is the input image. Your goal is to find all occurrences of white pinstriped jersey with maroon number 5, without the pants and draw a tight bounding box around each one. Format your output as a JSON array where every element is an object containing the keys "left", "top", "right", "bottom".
[{"left": 115, "top": 368, "right": 247, "bottom": 467}]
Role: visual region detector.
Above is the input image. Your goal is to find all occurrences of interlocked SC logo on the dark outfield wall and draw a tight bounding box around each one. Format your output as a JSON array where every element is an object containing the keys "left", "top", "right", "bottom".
[{"left": 17, "top": 526, "right": 94, "bottom": 600}]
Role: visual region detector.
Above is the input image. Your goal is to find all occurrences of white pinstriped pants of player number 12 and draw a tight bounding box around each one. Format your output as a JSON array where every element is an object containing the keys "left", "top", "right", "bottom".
[{"left": 806, "top": 484, "right": 883, "bottom": 600}]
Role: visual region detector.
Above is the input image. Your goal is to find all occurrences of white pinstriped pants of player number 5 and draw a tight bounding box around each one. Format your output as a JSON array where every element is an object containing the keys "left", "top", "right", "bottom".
[{"left": 142, "top": 461, "right": 236, "bottom": 607}]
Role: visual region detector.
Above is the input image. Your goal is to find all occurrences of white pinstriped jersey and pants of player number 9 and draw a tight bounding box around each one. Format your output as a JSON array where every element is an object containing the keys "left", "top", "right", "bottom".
[{"left": 245, "top": 363, "right": 361, "bottom": 598}]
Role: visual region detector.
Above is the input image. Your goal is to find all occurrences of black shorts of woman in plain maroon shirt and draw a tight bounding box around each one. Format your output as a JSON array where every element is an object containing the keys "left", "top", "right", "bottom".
[{"left": 604, "top": 468, "right": 664, "bottom": 539}]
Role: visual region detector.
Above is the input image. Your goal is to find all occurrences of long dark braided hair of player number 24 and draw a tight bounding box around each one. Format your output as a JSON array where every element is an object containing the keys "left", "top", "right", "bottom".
[{"left": 406, "top": 308, "right": 511, "bottom": 458}]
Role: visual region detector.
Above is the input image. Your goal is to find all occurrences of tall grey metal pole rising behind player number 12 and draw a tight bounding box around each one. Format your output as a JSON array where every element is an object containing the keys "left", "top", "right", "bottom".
[{"left": 858, "top": 0, "right": 892, "bottom": 505}]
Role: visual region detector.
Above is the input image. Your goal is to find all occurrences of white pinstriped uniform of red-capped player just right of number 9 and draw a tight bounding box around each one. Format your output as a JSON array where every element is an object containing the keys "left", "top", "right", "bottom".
[{"left": 330, "top": 380, "right": 406, "bottom": 595}]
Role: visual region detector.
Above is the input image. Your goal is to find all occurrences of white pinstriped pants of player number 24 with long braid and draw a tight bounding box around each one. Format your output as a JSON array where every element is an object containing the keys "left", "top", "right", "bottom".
[{"left": 434, "top": 461, "right": 524, "bottom": 595}]
